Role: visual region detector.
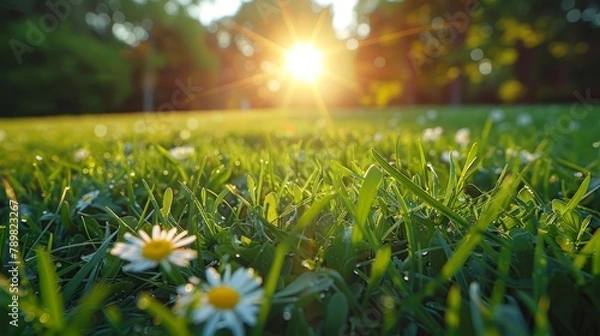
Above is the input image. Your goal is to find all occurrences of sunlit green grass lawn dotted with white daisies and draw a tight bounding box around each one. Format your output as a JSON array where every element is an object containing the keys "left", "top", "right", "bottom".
[{"left": 0, "top": 106, "right": 600, "bottom": 336}]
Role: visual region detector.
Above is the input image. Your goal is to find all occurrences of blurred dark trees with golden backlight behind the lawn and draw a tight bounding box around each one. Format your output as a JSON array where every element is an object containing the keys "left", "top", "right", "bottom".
[{"left": 0, "top": 0, "right": 600, "bottom": 116}]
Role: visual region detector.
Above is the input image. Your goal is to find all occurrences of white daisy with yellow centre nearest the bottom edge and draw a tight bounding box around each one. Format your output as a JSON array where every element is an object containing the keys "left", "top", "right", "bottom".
[{"left": 174, "top": 265, "right": 264, "bottom": 335}]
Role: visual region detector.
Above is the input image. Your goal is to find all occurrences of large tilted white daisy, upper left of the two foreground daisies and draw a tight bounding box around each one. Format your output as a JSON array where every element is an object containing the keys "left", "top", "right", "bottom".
[{"left": 110, "top": 225, "right": 198, "bottom": 272}]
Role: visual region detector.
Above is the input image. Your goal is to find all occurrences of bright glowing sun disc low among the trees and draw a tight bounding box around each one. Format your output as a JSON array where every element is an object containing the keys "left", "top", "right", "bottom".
[{"left": 285, "top": 43, "right": 323, "bottom": 83}]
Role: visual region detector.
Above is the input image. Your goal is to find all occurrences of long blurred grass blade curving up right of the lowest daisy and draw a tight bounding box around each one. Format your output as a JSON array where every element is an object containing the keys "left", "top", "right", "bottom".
[{"left": 252, "top": 194, "right": 335, "bottom": 336}]
